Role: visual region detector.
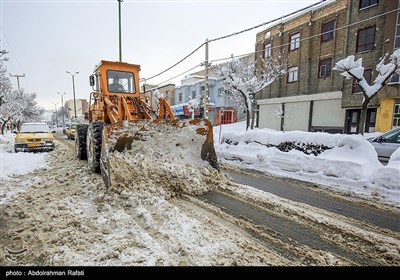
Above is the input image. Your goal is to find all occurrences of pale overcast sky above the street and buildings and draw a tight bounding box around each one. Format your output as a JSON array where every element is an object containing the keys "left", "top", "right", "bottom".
[{"left": 0, "top": 0, "right": 319, "bottom": 110}]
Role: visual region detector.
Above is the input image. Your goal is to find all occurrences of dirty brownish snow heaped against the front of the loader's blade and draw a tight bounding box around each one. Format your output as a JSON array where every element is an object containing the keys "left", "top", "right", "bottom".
[{"left": 109, "top": 122, "right": 225, "bottom": 199}]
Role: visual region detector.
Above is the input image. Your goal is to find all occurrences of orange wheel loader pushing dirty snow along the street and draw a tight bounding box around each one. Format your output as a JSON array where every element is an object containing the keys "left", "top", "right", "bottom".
[{"left": 75, "top": 60, "right": 219, "bottom": 187}]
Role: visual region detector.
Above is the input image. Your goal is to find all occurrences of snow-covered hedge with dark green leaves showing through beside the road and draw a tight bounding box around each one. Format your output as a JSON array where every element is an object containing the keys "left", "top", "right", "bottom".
[{"left": 217, "top": 130, "right": 381, "bottom": 179}]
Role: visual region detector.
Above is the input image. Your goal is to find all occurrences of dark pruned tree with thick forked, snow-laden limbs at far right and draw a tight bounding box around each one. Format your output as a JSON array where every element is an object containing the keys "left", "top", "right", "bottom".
[{"left": 333, "top": 50, "right": 400, "bottom": 135}]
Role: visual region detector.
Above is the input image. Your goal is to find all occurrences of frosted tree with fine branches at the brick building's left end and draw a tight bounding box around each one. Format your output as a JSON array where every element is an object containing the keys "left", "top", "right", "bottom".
[{"left": 217, "top": 55, "right": 286, "bottom": 130}]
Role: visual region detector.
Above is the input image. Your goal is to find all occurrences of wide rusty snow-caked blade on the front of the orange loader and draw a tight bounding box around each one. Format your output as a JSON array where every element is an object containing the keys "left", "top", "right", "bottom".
[{"left": 100, "top": 119, "right": 219, "bottom": 187}]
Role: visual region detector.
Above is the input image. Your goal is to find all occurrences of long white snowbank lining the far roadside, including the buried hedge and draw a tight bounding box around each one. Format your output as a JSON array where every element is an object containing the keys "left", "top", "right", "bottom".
[{"left": 214, "top": 122, "right": 400, "bottom": 205}]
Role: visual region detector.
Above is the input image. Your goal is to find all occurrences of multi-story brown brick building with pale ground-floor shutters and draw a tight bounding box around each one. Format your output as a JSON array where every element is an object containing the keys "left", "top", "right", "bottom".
[{"left": 256, "top": 0, "right": 400, "bottom": 133}]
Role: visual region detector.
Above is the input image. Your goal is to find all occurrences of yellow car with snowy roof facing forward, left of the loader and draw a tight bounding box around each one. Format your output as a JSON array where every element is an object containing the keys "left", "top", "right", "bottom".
[{"left": 14, "top": 123, "right": 55, "bottom": 153}]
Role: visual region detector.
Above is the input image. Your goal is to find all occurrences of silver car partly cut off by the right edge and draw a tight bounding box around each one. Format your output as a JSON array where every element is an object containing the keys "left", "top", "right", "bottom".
[{"left": 368, "top": 127, "right": 400, "bottom": 164}]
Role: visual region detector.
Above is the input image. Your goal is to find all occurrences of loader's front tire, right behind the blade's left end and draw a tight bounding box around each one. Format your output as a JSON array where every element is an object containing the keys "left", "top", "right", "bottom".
[{"left": 86, "top": 121, "right": 104, "bottom": 173}]
